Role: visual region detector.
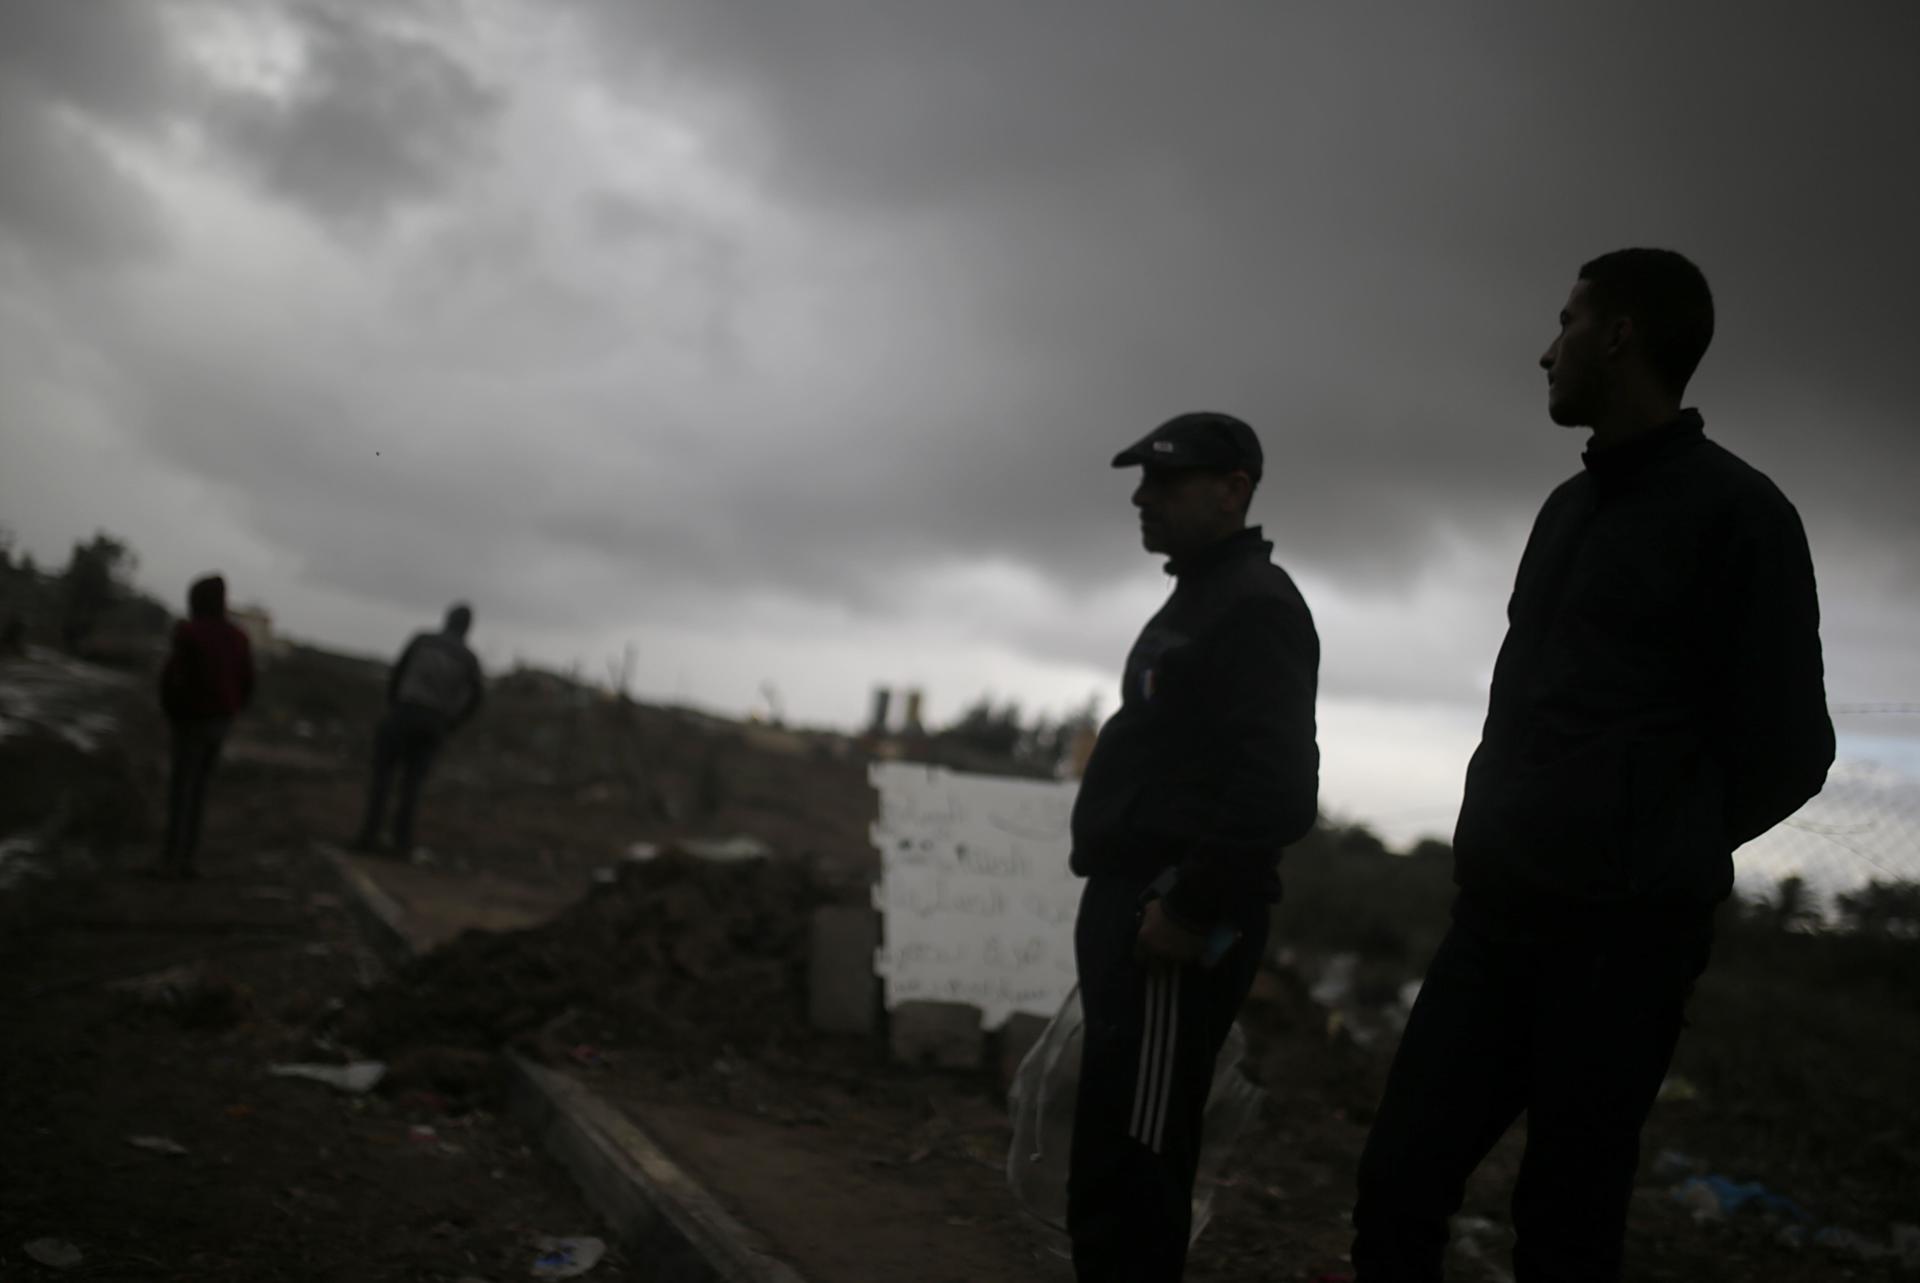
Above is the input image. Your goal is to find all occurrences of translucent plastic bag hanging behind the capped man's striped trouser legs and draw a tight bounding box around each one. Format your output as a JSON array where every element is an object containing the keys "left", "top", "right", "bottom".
[{"left": 1006, "top": 985, "right": 1267, "bottom": 1252}]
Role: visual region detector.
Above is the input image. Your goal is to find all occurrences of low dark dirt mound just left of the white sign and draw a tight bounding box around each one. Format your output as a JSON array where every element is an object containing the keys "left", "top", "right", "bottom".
[{"left": 342, "top": 851, "right": 822, "bottom": 1058}]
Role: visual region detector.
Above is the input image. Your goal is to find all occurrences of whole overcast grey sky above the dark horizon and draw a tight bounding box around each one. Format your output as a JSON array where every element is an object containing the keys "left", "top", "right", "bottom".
[{"left": 0, "top": 0, "right": 1920, "bottom": 830}]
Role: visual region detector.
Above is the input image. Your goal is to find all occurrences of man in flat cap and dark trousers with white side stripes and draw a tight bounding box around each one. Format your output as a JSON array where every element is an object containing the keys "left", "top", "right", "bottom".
[{"left": 1068, "top": 413, "right": 1319, "bottom": 1283}]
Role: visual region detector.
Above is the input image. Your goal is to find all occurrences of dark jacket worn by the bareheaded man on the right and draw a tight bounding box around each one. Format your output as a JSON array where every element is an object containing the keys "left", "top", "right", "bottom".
[{"left": 1453, "top": 411, "right": 1834, "bottom": 905}]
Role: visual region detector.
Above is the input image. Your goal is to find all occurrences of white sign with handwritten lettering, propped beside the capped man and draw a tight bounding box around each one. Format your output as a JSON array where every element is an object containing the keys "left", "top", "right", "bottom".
[{"left": 868, "top": 763, "right": 1083, "bottom": 1029}]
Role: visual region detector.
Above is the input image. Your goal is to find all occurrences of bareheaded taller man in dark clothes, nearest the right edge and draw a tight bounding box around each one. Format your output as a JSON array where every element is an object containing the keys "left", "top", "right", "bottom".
[{"left": 1354, "top": 250, "right": 1834, "bottom": 1283}]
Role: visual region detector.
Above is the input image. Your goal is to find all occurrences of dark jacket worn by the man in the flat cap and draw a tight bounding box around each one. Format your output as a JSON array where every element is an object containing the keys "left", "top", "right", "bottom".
[{"left": 1073, "top": 528, "right": 1319, "bottom": 926}]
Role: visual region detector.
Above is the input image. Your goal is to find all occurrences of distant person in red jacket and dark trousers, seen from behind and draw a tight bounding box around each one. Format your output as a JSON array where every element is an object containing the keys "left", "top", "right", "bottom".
[{"left": 159, "top": 574, "right": 253, "bottom": 878}]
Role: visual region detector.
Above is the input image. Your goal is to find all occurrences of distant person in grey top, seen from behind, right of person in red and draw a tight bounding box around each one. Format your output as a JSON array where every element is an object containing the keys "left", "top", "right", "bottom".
[{"left": 353, "top": 605, "right": 484, "bottom": 859}]
